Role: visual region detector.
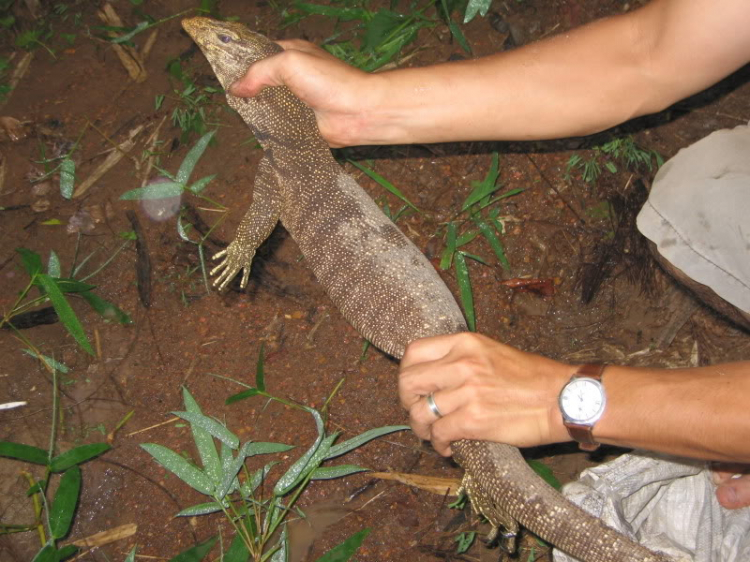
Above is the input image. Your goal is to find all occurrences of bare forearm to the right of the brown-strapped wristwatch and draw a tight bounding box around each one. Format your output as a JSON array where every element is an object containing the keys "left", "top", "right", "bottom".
[{"left": 592, "top": 361, "right": 750, "bottom": 463}]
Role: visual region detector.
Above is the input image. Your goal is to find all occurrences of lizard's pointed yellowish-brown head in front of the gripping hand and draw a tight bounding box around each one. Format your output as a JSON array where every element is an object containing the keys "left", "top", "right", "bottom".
[{"left": 182, "top": 18, "right": 281, "bottom": 89}]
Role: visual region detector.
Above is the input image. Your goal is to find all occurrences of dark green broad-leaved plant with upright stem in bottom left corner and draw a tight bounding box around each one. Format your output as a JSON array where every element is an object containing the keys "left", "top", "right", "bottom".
[{"left": 0, "top": 368, "right": 110, "bottom": 562}]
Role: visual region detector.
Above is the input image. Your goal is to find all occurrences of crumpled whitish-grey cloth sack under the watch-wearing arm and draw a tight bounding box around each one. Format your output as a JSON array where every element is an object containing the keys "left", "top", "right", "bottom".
[{"left": 554, "top": 452, "right": 750, "bottom": 562}]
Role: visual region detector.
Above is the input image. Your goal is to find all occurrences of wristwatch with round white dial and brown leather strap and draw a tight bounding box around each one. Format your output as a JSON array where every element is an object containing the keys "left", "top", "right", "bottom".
[{"left": 558, "top": 363, "right": 607, "bottom": 451}]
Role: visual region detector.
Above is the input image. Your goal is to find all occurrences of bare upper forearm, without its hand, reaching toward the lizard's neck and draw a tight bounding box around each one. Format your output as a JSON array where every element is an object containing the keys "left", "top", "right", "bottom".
[{"left": 360, "top": 0, "right": 747, "bottom": 144}]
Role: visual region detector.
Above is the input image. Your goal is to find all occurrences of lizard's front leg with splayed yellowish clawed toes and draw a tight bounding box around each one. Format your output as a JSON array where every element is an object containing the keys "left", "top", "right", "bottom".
[{"left": 210, "top": 157, "right": 281, "bottom": 291}]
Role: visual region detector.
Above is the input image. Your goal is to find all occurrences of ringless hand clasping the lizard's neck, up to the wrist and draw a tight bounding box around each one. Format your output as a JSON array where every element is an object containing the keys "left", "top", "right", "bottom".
[{"left": 229, "top": 39, "right": 380, "bottom": 148}]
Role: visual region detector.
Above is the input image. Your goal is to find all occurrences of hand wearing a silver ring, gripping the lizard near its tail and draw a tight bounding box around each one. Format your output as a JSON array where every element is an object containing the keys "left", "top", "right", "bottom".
[{"left": 399, "top": 333, "right": 575, "bottom": 456}]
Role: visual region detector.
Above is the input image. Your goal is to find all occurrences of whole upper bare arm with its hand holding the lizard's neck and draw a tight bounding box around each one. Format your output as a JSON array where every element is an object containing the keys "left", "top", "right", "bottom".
[{"left": 231, "top": 0, "right": 750, "bottom": 147}]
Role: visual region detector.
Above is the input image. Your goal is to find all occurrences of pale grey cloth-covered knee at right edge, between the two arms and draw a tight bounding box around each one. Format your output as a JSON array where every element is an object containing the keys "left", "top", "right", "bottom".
[{"left": 637, "top": 121, "right": 750, "bottom": 313}]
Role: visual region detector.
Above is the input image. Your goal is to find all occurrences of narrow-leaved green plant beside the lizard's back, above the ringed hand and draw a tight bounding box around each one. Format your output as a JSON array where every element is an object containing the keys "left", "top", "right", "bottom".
[{"left": 440, "top": 152, "right": 523, "bottom": 331}]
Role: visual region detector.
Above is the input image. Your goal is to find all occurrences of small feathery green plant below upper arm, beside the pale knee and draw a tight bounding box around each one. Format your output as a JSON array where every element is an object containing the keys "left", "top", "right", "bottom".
[{"left": 565, "top": 136, "right": 664, "bottom": 184}]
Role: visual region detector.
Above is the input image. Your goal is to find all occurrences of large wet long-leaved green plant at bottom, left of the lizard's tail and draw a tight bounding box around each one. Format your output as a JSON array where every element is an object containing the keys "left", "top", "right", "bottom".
[{"left": 141, "top": 368, "right": 408, "bottom": 562}]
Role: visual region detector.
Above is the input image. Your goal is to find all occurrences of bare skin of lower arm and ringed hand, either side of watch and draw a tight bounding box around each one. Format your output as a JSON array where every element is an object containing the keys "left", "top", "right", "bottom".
[{"left": 399, "top": 333, "right": 750, "bottom": 508}]
